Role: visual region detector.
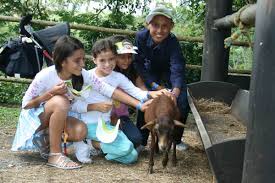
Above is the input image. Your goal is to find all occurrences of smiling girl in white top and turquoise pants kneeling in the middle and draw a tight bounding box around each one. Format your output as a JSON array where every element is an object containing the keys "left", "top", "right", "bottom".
[{"left": 73, "top": 39, "right": 163, "bottom": 164}]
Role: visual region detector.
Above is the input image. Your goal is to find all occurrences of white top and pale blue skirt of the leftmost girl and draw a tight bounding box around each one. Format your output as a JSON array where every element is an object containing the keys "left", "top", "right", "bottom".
[{"left": 11, "top": 66, "right": 115, "bottom": 151}]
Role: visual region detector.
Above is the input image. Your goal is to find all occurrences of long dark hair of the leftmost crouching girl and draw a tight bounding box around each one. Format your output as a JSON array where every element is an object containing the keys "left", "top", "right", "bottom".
[{"left": 53, "top": 35, "right": 84, "bottom": 91}]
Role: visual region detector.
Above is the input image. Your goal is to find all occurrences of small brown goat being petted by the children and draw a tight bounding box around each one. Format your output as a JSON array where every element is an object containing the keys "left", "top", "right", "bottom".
[{"left": 141, "top": 94, "right": 185, "bottom": 173}]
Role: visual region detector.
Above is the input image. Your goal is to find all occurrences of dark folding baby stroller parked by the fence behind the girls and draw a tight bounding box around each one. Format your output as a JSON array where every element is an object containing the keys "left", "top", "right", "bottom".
[{"left": 0, "top": 15, "right": 70, "bottom": 79}]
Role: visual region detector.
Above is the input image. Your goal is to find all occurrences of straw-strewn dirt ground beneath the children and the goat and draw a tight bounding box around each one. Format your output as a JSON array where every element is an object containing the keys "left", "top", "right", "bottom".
[{"left": 0, "top": 115, "right": 213, "bottom": 183}]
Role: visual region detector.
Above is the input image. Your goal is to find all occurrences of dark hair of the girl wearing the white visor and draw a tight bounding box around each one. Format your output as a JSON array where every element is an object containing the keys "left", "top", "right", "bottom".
[{"left": 109, "top": 35, "right": 137, "bottom": 83}]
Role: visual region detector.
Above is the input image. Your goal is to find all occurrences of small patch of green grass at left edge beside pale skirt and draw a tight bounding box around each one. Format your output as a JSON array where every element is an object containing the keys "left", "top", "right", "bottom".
[{"left": 0, "top": 106, "right": 20, "bottom": 128}]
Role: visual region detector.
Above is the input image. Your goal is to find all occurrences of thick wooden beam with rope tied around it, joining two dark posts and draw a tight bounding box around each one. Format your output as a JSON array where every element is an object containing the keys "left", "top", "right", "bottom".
[{"left": 214, "top": 4, "right": 257, "bottom": 29}]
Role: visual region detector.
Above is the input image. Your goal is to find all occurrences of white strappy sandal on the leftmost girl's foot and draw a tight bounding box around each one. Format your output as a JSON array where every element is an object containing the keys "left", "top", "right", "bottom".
[{"left": 47, "top": 153, "right": 82, "bottom": 170}]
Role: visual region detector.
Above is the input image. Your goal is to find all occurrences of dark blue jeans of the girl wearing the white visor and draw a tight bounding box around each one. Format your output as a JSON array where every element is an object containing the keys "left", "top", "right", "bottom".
[{"left": 120, "top": 116, "right": 142, "bottom": 147}]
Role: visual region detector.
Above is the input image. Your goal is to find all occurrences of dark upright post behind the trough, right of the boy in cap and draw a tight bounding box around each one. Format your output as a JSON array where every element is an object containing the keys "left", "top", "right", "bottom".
[{"left": 201, "top": 0, "right": 232, "bottom": 81}]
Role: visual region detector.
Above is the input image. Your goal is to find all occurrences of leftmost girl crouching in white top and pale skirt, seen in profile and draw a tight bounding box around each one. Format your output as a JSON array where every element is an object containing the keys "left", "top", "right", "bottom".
[{"left": 12, "top": 36, "right": 150, "bottom": 169}]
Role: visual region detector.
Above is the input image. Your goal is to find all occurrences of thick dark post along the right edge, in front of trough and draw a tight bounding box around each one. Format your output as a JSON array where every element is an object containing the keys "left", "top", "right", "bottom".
[{"left": 242, "top": 0, "right": 275, "bottom": 183}]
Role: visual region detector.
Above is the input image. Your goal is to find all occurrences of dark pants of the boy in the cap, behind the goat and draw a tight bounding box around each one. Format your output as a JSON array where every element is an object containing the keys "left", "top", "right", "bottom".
[{"left": 137, "top": 90, "right": 190, "bottom": 146}]
